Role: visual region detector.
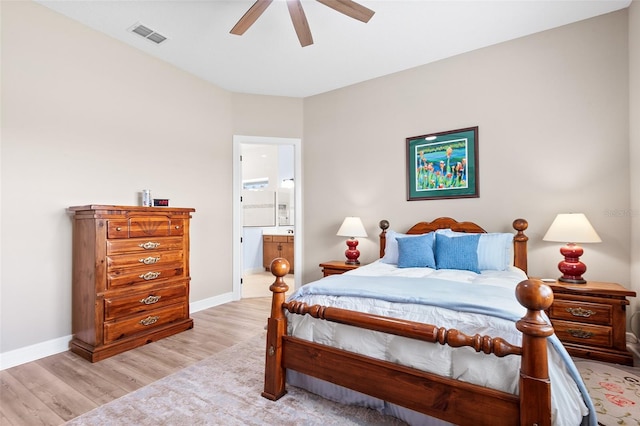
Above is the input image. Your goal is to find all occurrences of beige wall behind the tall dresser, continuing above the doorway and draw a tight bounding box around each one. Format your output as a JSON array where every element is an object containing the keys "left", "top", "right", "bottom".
[{"left": 0, "top": 2, "right": 302, "bottom": 353}]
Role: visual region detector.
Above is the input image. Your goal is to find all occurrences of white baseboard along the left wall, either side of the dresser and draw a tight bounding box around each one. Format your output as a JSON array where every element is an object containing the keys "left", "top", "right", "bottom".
[{"left": 0, "top": 293, "right": 234, "bottom": 371}]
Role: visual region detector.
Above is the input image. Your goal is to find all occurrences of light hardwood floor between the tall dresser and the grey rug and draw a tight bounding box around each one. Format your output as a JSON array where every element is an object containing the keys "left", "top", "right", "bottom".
[{"left": 0, "top": 298, "right": 271, "bottom": 426}]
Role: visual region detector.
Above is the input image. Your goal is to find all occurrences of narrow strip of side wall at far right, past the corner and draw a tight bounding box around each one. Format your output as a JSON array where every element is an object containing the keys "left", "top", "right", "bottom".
[{"left": 627, "top": 0, "right": 640, "bottom": 334}]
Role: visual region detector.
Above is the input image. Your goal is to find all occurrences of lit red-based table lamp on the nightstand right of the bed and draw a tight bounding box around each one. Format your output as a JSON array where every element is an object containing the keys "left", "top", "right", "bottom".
[{"left": 542, "top": 213, "right": 602, "bottom": 284}]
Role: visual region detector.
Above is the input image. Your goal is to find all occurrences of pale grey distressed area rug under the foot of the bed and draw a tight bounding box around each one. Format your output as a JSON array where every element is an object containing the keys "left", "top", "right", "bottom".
[{"left": 66, "top": 333, "right": 405, "bottom": 426}]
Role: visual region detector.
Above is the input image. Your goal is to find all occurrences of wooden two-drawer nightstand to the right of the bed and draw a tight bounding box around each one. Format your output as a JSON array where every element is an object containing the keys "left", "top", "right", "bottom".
[{"left": 546, "top": 281, "right": 636, "bottom": 365}]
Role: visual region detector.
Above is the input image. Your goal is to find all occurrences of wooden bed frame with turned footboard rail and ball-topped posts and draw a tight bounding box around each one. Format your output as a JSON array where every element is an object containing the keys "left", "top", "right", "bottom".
[{"left": 262, "top": 218, "right": 553, "bottom": 426}]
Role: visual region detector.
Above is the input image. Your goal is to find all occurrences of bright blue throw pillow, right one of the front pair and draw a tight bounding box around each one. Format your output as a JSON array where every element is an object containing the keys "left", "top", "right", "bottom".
[{"left": 434, "top": 234, "right": 480, "bottom": 274}]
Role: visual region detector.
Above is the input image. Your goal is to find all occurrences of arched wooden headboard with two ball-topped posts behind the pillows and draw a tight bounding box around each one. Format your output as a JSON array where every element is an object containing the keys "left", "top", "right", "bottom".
[{"left": 378, "top": 217, "right": 529, "bottom": 274}]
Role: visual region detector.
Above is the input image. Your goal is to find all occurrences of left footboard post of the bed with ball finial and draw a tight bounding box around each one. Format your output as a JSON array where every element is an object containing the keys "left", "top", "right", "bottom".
[{"left": 262, "top": 258, "right": 289, "bottom": 401}]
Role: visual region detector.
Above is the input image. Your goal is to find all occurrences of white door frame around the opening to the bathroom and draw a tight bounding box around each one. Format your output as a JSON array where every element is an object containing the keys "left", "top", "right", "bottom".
[{"left": 232, "top": 135, "right": 303, "bottom": 300}]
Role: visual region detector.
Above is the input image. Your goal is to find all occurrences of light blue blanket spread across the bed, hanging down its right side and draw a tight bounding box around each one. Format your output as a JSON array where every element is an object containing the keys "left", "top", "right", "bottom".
[{"left": 289, "top": 274, "right": 598, "bottom": 426}]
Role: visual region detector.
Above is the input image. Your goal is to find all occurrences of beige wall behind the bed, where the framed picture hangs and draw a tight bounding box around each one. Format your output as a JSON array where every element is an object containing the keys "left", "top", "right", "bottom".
[{"left": 303, "top": 10, "right": 637, "bottom": 296}]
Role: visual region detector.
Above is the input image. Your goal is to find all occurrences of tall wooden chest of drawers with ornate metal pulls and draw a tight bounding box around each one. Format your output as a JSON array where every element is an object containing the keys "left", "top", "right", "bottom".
[{"left": 69, "top": 205, "right": 195, "bottom": 362}]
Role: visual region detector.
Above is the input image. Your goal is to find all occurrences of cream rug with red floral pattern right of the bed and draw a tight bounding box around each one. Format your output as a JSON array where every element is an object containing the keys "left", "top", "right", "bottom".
[{"left": 575, "top": 361, "right": 640, "bottom": 426}]
